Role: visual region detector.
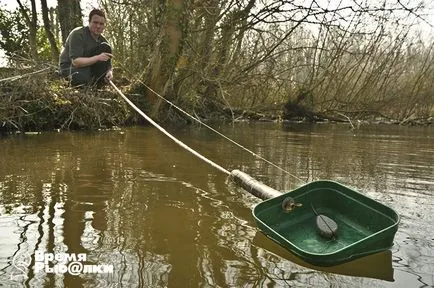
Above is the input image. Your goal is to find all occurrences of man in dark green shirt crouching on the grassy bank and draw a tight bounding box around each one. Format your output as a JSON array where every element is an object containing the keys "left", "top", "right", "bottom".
[{"left": 59, "top": 9, "right": 113, "bottom": 86}]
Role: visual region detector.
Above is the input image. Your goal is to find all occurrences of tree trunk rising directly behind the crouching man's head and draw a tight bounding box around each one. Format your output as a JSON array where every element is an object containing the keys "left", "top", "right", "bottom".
[{"left": 57, "top": 0, "right": 83, "bottom": 43}]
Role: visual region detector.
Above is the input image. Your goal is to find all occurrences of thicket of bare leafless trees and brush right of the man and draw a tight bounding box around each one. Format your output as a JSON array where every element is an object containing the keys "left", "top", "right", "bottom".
[{"left": 97, "top": 0, "right": 433, "bottom": 119}]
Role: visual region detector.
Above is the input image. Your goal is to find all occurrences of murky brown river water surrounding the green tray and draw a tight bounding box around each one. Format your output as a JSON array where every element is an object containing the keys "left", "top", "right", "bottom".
[{"left": 0, "top": 123, "right": 434, "bottom": 287}]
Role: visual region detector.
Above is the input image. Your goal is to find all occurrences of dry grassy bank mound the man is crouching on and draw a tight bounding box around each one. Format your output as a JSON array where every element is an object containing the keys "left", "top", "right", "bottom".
[{"left": 0, "top": 69, "right": 132, "bottom": 132}]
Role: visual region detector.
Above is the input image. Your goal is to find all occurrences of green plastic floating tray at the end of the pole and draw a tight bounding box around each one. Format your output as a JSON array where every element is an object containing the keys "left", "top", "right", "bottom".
[{"left": 253, "top": 181, "right": 399, "bottom": 266}]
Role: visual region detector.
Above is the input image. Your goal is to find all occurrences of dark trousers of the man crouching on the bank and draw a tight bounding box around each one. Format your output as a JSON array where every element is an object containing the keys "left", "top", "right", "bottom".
[{"left": 64, "top": 42, "right": 112, "bottom": 86}]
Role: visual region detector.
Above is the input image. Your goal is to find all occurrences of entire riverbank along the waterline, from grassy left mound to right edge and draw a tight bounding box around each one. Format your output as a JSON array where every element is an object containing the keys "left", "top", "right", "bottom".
[{"left": 0, "top": 68, "right": 434, "bottom": 132}]
